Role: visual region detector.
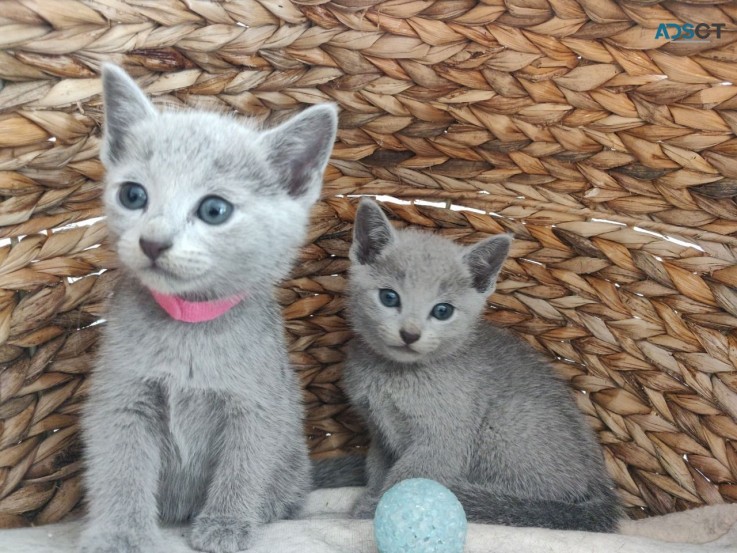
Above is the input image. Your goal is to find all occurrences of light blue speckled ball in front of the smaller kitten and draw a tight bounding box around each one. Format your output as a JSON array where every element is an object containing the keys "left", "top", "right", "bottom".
[{"left": 374, "top": 478, "right": 468, "bottom": 553}]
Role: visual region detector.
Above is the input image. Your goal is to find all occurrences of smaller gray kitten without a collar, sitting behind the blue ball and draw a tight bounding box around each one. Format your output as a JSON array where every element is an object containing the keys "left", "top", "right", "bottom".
[{"left": 344, "top": 200, "right": 620, "bottom": 532}]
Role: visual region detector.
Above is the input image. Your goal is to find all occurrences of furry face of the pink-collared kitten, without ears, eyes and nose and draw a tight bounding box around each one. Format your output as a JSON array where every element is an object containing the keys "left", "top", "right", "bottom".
[{"left": 105, "top": 113, "right": 308, "bottom": 296}]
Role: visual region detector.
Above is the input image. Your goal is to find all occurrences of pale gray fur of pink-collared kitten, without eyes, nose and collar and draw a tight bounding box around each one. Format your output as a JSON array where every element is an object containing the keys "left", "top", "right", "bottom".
[{"left": 81, "top": 65, "right": 337, "bottom": 553}]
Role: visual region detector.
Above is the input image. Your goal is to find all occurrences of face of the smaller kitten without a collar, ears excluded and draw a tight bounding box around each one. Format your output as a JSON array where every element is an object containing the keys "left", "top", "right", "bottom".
[{"left": 351, "top": 231, "right": 484, "bottom": 363}]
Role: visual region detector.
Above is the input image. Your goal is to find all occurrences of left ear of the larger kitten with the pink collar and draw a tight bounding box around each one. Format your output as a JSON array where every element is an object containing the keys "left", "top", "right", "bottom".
[{"left": 101, "top": 63, "right": 156, "bottom": 163}]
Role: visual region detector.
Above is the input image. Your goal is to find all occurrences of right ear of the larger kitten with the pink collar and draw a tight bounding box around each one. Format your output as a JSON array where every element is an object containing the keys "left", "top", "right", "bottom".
[{"left": 261, "top": 104, "right": 338, "bottom": 203}]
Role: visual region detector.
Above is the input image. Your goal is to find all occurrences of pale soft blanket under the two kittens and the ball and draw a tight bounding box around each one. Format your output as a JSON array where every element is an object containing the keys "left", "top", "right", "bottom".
[{"left": 5, "top": 488, "right": 737, "bottom": 553}]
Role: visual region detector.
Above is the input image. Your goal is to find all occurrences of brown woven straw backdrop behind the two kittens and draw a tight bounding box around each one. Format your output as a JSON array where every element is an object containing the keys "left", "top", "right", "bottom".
[{"left": 0, "top": 0, "right": 737, "bottom": 526}]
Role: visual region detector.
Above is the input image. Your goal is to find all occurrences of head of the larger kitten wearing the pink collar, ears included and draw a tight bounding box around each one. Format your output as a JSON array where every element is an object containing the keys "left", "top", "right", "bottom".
[{"left": 101, "top": 65, "right": 337, "bottom": 299}]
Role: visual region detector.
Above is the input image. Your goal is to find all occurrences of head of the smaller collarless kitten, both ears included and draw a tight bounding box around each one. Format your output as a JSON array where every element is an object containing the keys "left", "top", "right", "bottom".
[{"left": 349, "top": 199, "right": 512, "bottom": 363}]
